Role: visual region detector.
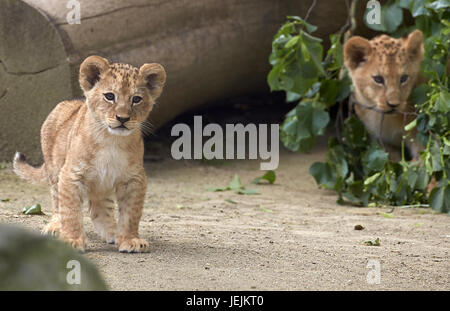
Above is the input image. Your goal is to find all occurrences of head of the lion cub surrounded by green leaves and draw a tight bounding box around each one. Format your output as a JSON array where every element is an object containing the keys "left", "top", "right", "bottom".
[{"left": 344, "top": 30, "right": 424, "bottom": 113}]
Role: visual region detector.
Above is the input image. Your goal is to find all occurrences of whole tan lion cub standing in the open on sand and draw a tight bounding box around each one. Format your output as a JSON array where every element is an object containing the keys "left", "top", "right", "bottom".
[{"left": 14, "top": 56, "right": 166, "bottom": 252}]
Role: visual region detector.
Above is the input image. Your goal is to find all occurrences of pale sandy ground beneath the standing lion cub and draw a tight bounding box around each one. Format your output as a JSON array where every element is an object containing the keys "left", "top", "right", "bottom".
[{"left": 0, "top": 144, "right": 450, "bottom": 290}]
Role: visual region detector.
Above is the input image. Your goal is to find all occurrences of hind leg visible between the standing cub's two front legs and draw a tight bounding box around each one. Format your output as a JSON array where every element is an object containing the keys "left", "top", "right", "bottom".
[{"left": 89, "top": 195, "right": 117, "bottom": 244}]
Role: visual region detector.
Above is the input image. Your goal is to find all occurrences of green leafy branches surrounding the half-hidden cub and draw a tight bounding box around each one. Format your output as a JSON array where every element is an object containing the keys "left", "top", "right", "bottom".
[{"left": 267, "top": 0, "right": 450, "bottom": 212}]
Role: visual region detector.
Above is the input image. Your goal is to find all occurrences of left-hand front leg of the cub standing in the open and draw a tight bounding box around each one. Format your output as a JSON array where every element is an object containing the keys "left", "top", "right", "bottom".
[{"left": 58, "top": 171, "right": 86, "bottom": 251}]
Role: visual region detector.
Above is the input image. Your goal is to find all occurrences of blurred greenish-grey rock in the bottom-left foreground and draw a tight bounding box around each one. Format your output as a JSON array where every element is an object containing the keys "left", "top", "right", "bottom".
[{"left": 0, "top": 225, "right": 107, "bottom": 290}]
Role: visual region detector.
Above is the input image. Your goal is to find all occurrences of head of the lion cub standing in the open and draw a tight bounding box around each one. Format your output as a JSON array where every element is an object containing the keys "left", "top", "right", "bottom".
[{"left": 80, "top": 56, "right": 166, "bottom": 136}]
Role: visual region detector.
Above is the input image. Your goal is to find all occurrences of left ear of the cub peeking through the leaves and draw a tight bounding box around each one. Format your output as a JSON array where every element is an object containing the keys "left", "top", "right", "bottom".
[{"left": 344, "top": 36, "right": 372, "bottom": 70}]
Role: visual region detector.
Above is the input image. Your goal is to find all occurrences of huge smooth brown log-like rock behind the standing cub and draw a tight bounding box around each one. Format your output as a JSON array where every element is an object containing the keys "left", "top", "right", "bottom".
[{"left": 0, "top": 0, "right": 372, "bottom": 163}]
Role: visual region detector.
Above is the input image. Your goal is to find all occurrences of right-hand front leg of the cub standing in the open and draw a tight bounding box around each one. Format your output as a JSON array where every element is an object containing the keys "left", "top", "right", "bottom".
[{"left": 116, "top": 173, "right": 148, "bottom": 253}]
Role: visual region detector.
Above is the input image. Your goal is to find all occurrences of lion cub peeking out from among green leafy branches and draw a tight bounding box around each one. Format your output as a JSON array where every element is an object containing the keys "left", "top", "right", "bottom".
[{"left": 344, "top": 30, "right": 424, "bottom": 160}]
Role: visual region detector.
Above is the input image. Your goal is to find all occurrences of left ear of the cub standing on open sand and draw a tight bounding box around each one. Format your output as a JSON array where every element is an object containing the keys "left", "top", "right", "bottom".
[{"left": 79, "top": 55, "right": 109, "bottom": 92}]
